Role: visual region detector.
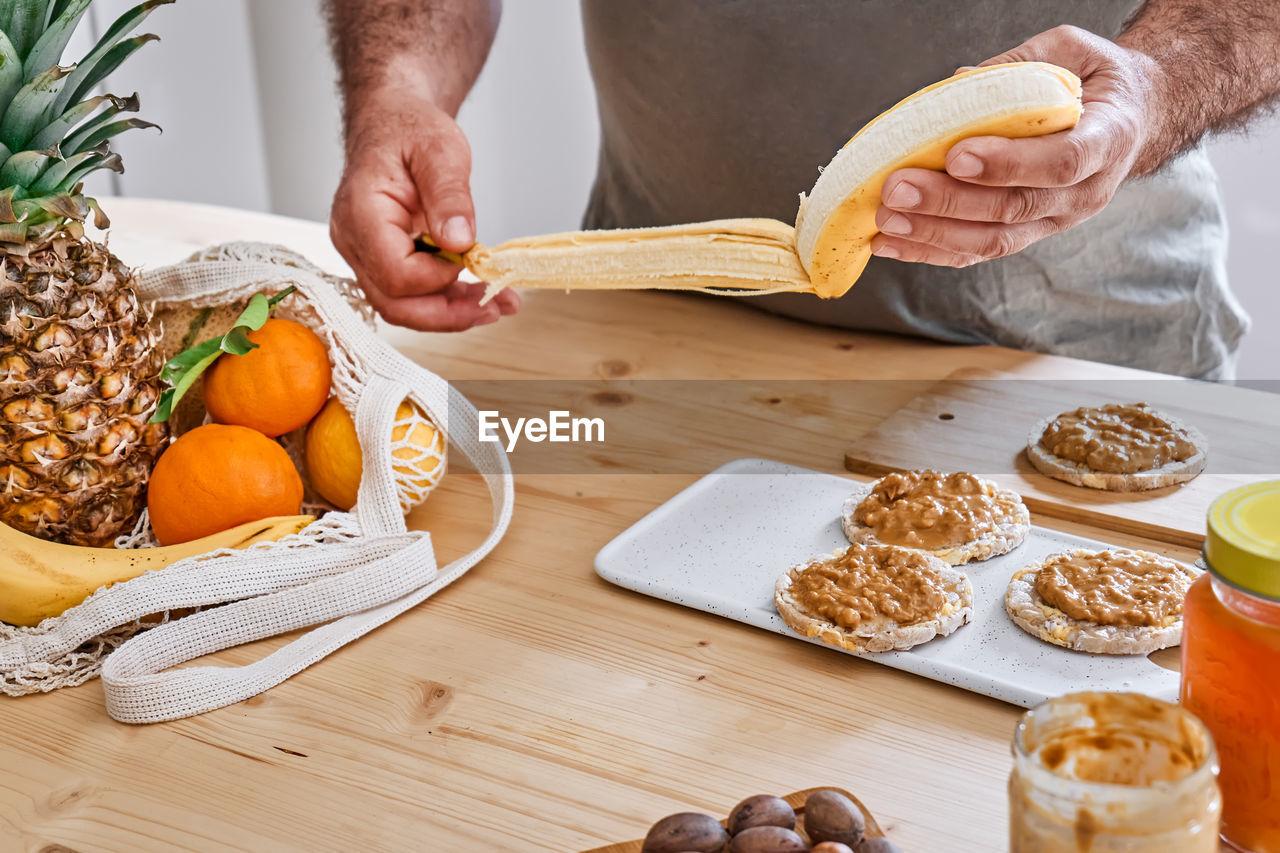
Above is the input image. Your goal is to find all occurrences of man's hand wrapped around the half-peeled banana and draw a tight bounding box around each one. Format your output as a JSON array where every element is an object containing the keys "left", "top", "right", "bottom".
[{"left": 872, "top": 27, "right": 1162, "bottom": 266}]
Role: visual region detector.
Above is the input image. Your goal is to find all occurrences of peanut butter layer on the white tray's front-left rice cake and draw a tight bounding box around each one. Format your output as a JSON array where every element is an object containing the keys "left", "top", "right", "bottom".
[{"left": 791, "top": 544, "right": 946, "bottom": 631}]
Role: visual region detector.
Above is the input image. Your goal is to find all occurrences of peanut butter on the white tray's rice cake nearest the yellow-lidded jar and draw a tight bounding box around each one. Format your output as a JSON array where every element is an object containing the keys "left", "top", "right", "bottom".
[{"left": 1036, "top": 551, "right": 1193, "bottom": 625}]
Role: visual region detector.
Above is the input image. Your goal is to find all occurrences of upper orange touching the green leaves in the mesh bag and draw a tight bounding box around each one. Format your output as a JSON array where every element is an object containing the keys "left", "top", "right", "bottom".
[{"left": 205, "top": 318, "right": 333, "bottom": 438}]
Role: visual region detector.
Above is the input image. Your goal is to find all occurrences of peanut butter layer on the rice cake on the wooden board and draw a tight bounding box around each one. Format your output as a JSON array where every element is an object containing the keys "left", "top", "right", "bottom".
[{"left": 1041, "top": 403, "right": 1197, "bottom": 474}]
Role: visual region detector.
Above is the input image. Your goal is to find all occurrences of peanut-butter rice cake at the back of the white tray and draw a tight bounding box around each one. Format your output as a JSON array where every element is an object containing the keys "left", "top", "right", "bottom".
[{"left": 841, "top": 469, "right": 1032, "bottom": 566}]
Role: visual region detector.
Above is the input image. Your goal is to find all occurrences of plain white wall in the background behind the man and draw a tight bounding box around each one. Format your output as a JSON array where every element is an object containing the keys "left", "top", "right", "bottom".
[{"left": 82, "top": 0, "right": 1280, "bottom": 379}]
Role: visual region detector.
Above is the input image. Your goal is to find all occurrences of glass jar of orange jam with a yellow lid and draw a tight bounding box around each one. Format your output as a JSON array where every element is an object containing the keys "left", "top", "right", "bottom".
[{"left": 1181, "top": 480, "right": 1280, "bottom": 853}]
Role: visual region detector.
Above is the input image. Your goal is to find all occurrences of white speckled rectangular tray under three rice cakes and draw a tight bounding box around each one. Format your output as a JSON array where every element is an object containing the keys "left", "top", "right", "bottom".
[{"left": 595, "top": 459, "right": 1178, "bottom": 707}]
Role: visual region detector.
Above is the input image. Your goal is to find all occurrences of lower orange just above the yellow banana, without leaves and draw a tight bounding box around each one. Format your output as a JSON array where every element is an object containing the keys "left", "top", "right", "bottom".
[{"left": 147, "top": 424, "right": 302, "bottom": 544}]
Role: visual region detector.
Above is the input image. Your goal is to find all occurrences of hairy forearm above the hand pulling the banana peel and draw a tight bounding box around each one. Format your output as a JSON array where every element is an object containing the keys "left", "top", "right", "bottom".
[{"left": 324, "top": 0, "right": 502, "bottom": 120}]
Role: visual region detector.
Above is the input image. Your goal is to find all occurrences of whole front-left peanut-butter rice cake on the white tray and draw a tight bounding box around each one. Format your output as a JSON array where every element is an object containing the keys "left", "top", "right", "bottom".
[{"left": 773, "top": 544, "right": 973, "bottom": 652}]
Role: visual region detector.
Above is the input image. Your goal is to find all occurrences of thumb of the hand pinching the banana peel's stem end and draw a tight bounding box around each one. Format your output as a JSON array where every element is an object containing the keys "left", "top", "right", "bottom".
[{"left": 407, "top": 124, "right": 476, "bottom": 252}]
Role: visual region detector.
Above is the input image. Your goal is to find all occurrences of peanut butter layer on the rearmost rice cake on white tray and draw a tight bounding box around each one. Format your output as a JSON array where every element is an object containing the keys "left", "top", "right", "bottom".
[{"left": 854, "top": 470, "right": 1001, "bottom": 551}]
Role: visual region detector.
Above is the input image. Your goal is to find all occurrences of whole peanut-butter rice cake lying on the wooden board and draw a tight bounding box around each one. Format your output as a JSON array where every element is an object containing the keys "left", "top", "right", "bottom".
[{"left": 1027, "top": 403, "right": 1208, "bottom": 492}]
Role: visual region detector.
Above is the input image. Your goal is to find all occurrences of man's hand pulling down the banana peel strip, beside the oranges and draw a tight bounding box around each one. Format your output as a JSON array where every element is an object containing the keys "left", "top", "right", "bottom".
[{"left": 329, "top": 92, "right": 520, "bottom": 332}]
